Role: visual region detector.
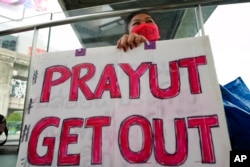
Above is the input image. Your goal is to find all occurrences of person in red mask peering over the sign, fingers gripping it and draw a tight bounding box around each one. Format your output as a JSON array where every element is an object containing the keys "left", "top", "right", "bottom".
[{"left": 117, "top": 11, "right": 160, "bottom": 52}]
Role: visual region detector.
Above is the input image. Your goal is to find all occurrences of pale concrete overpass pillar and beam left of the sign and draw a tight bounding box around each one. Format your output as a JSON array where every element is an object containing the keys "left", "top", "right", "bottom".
[{"left": 0, "top": 48, "right": 30, "bottom": 116}]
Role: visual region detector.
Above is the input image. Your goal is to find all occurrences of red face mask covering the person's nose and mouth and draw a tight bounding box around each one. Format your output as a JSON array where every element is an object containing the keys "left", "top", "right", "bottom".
[{"left": 131, "top": 23, "right": 160, "bottom": 41}]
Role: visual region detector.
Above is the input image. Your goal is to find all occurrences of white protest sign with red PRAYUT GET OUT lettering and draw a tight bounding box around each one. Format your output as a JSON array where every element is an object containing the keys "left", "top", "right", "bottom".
[{"left": 17, "top": 37, "right": 230, "bottom": 167}]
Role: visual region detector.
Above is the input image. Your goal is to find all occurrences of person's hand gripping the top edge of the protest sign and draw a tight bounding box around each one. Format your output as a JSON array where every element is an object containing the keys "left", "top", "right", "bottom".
[{"left": 117, "top": 33, "right": 148, "bottom": 52}]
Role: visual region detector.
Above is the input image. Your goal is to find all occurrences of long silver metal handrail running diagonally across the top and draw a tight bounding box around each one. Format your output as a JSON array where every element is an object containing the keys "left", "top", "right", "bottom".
[{"left": 0, "top": 0, "right": 236, "bottom": 36}]
